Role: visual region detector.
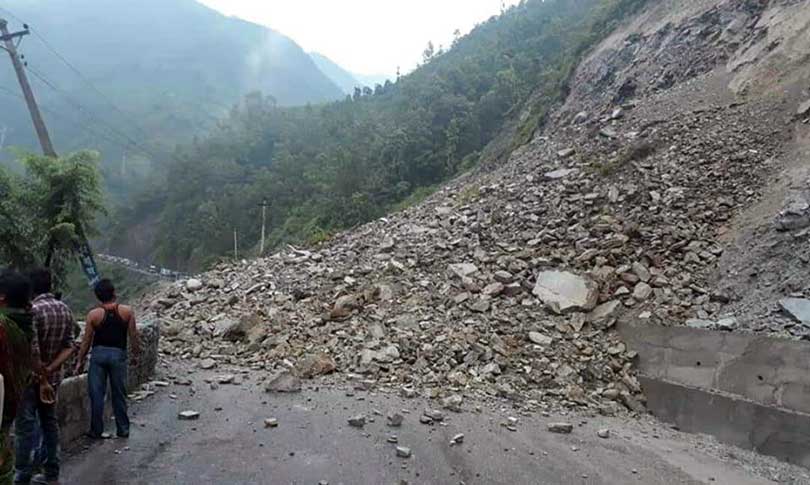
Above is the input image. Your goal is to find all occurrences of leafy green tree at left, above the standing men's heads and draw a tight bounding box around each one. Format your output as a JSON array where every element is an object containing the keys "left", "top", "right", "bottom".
[{"left": 0, "top": 151, "right": 104, "bottom": 284}]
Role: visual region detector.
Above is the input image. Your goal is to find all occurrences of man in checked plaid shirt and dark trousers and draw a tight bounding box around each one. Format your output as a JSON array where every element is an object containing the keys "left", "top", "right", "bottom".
[{"left": 15, "top": 269, "right": 74, "bottom": 485}]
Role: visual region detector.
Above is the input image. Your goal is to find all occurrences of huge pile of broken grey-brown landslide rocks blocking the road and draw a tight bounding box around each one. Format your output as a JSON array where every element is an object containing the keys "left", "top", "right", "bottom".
[{"left": 149, "top": 2, "right": 802, "bottom": 408}]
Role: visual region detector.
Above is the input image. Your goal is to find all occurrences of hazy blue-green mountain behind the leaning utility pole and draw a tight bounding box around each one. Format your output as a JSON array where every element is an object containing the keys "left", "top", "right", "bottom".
[{"left": 0, "top": 0, "right": 344, "bottom": 193}]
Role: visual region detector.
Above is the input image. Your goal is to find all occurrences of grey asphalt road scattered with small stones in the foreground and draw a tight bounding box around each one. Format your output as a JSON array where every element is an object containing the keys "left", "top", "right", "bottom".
[{"left": 62, "top": 364, "right": 771, "bottom": 485}]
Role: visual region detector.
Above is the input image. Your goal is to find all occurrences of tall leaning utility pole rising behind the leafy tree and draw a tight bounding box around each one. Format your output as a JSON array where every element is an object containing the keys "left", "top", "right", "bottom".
[{"left": 0, "top": 18, "right": 101, "bottom": 285}]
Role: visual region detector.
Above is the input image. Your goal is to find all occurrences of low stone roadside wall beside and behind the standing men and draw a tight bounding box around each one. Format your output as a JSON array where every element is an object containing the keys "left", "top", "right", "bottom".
[{"left": 56, "top": 321, "right": 160, "bottom": 446}]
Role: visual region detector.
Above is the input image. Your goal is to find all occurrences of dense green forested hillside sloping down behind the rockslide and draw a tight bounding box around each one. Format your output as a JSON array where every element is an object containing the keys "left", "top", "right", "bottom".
[{"left": 113, "top": 0, "right": 644, "bottom": 268}]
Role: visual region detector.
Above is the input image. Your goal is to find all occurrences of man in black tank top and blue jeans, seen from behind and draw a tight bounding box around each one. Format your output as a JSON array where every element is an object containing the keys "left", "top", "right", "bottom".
[{"left": 76, "top": 279, "right": 140, "bottom": 439}]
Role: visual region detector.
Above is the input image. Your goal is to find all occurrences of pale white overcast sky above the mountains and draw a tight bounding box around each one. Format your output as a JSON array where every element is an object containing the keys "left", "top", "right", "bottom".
[{"left": 199, "top": 0, "right": 518, "bottom": 76}]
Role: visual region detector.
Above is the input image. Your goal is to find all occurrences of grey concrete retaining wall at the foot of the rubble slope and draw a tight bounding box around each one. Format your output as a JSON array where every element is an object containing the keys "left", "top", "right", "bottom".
[{"left": 618, "top": 322, "right": 810, "bottom": 467}]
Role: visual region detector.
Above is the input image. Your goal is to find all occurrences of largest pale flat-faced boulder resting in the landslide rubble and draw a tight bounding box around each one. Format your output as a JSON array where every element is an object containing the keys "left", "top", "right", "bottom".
[{"left": 533, "top": 271, "right": 599, "bottom": 315}]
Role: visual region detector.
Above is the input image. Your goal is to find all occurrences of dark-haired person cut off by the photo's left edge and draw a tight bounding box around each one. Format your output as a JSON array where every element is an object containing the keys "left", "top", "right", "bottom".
[{"left": 0, "top": 270, "right": 39, "bottom": 485}]
